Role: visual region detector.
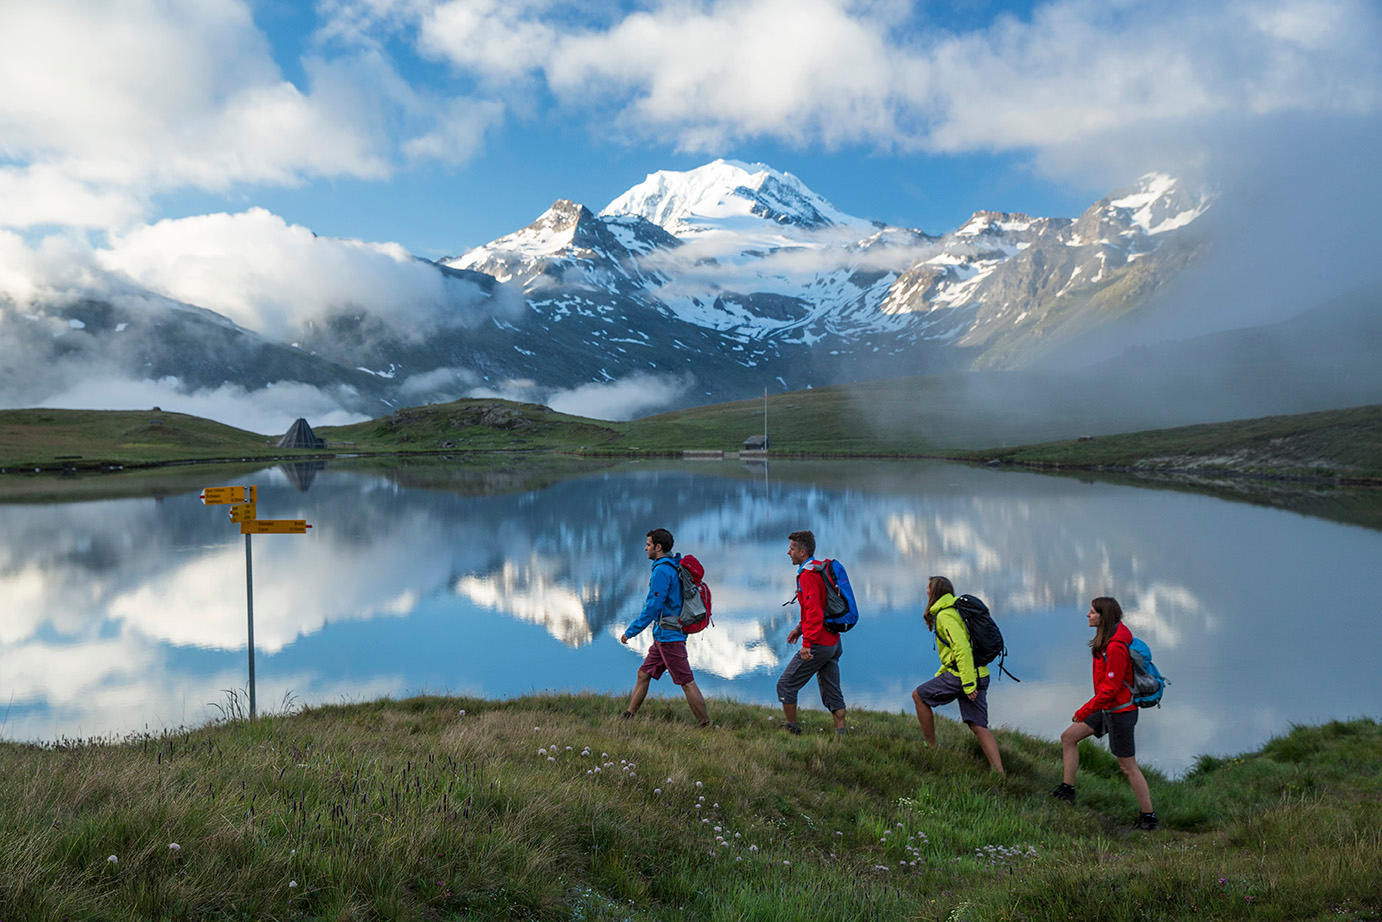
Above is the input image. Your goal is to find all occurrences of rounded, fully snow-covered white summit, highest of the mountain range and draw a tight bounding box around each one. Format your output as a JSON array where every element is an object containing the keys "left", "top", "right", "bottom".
[{"left": 601, "top": 159, "right": 872, "bottom": 236}]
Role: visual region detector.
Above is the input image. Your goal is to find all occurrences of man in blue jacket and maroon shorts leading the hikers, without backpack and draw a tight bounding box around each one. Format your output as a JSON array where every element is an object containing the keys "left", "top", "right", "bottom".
[{"left": 619, "top": 528, "right": 710, "bottom": 727}]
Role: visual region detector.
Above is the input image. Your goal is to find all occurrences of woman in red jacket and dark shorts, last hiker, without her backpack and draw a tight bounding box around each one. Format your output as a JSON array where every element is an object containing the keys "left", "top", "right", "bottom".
[{"left": 1050, "top": 596, "right": 1157, "bottom": 829}]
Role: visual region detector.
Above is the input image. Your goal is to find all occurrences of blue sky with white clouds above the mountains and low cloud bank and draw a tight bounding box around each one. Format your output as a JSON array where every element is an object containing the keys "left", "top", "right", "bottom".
[{"left": 0, "top": 0, "right": 1382, "bottom": 259}]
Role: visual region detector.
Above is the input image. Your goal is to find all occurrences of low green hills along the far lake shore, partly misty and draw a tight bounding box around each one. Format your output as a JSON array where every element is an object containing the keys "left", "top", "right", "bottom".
[{"left": 0, "top": 395, "right": 1382, "bottom": 482}]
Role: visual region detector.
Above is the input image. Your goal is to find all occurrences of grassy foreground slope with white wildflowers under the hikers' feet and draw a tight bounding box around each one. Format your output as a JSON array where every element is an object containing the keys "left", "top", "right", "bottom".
[{"left": 0, "top": 695, "right": 1382, "bottom": 922}]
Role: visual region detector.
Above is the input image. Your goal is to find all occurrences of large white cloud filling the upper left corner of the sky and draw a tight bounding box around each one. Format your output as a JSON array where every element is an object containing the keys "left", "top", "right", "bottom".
[{"left": 0, "top": 0, "right": 496, "bottom": 228}]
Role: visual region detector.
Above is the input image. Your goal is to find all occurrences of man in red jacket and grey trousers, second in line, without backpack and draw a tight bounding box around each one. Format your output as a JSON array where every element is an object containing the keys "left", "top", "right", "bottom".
[{"left": 778, "top": 531, "right": 846, "bottom": 735}]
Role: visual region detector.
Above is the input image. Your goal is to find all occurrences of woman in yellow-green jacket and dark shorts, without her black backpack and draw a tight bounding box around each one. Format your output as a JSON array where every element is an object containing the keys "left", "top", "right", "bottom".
[{"left": 912, "top": 576, "right": 1003, "bottom": 774}]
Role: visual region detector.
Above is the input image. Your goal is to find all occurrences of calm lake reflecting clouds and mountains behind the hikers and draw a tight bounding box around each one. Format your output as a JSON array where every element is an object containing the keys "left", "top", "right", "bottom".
[{"left": 0, "top": 459, "right": 1382, "bottom": 771}]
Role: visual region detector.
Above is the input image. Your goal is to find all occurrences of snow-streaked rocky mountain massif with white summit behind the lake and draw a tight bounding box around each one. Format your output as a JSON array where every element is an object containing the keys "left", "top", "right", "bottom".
[{"left": 0, "top": 160, "right": 1211, "bottom": 425}]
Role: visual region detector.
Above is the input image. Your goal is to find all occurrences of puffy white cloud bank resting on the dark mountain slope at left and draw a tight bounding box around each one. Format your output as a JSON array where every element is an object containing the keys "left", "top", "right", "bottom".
[{"left": 98, "top": 209, "right": 486, "bottom": 340}]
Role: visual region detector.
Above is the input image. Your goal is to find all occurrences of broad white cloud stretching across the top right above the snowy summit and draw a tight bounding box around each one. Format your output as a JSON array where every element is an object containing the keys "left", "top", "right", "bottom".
[{"left": 419, "top": 0, "right": 1382, "bottom": 159}]
